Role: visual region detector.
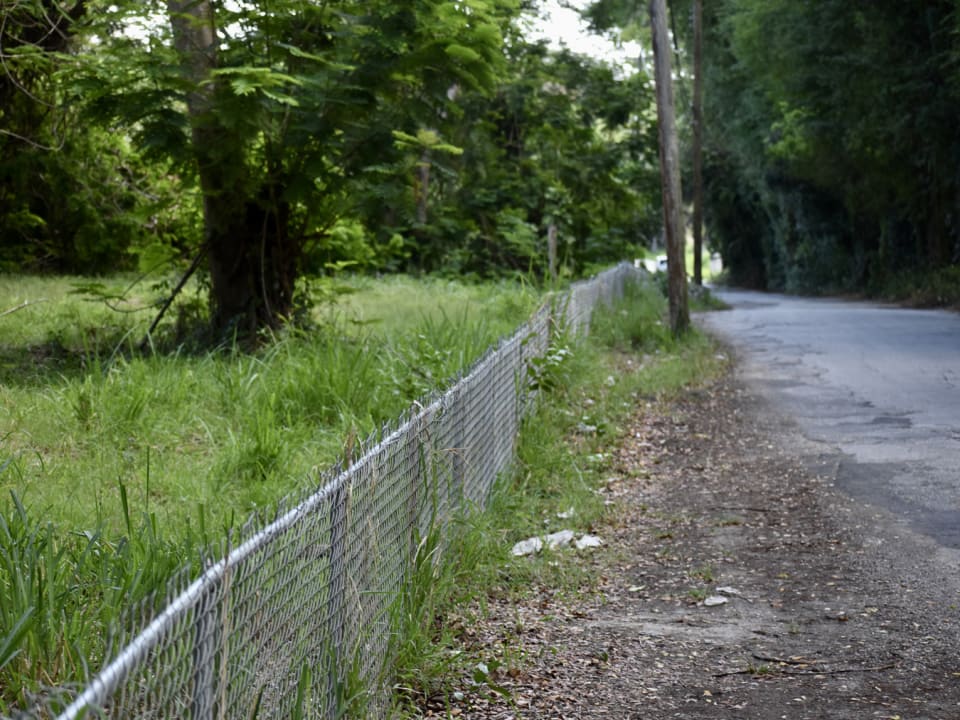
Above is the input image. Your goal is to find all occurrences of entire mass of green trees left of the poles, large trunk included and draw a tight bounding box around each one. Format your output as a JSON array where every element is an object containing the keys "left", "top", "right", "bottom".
[{"left": 0, "top": 0, "right": 658, "bottom": 333}]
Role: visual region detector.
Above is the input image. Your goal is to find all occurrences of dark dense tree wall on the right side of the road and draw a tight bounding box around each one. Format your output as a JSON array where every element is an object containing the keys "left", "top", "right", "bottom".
[{"left": 705, "top": 0, "right": 960, "bottom": 292}]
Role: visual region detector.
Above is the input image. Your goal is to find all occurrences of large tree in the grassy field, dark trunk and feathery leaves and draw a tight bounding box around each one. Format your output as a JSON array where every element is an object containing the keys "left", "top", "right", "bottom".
[{"left": 81, "top": 0, "right": 518, "bottom": 335}]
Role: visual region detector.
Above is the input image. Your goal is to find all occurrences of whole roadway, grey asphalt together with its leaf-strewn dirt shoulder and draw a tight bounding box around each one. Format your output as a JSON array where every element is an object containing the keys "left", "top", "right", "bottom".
[{"left": 436, "top": 291, "right": 960, "bottom": 720}]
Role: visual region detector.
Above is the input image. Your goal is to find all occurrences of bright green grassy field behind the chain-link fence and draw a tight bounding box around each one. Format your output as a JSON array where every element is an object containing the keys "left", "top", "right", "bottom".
[{"left": 0, "top": 277, "right": 540, "bottom": 712}]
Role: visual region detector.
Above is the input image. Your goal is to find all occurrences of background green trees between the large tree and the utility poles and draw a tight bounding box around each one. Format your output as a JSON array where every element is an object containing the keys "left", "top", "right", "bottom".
[{"left": 356, "top": 39, "right": 658, "bottom": 276}]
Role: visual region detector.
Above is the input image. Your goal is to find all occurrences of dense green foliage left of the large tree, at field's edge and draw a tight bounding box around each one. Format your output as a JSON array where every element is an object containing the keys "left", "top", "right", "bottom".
[{"left": 0, "top": 0, "right": 196, "bottom": 272}]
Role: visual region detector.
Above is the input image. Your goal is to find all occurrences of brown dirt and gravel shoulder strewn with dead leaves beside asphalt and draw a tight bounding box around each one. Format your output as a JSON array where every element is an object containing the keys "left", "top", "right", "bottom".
[{"left": 426, "top": 366, "right": 960, "bottom": 720}]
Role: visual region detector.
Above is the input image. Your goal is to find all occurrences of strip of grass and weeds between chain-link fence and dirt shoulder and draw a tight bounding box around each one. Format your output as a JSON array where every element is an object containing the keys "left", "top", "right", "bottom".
[{"left": 393, "top": 283, "right": 725, "bottom": 717}]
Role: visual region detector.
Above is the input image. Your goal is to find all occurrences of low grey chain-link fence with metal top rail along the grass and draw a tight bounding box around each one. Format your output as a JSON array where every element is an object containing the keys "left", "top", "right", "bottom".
[{"left": 24, "top": 264, "right": 640, "bottom": 720}]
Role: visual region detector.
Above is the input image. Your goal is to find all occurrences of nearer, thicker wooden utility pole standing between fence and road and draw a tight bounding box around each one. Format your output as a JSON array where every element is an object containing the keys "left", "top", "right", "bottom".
[{"left": 650, "top": 0, "right": 690, "bottom": 335}]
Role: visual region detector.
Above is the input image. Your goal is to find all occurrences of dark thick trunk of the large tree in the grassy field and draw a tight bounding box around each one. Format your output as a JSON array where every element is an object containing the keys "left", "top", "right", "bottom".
[{"left": 167, "top": 0, "right": 299, "bottom": 337}]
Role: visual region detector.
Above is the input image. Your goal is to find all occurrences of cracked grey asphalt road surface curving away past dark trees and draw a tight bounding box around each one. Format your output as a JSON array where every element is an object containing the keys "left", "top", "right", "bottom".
[{"left": 697, "top": 290, "right": 960, "bottom": 549}]
